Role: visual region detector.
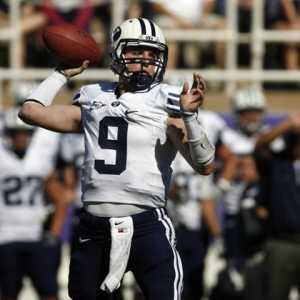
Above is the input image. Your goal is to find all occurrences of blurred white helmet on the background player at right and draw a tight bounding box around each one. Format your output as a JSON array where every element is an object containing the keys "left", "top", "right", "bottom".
[{"left": 231, "top": 88, "right": 267, "bottom": 135}]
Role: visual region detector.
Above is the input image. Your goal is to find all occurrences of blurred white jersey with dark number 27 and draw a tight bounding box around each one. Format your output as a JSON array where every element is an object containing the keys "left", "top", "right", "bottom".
[{"left": 0, "top": 128, "right": 59, "bottom": 244}]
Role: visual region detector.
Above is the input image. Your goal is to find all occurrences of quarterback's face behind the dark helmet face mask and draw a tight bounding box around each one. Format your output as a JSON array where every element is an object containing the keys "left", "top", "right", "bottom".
[{"left": 124, "top": 46, "right": 158, "bottom": 77}]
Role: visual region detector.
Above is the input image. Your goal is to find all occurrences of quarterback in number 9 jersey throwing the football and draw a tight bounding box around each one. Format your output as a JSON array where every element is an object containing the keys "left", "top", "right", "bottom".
[{"left": 19, "top": 19, "right": 214, "bottom": 300}]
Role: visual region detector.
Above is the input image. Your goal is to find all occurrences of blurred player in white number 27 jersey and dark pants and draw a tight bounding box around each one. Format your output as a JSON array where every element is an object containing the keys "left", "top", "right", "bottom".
[{"left": 0, "top": 94, "right": 64, "bottom": 300}]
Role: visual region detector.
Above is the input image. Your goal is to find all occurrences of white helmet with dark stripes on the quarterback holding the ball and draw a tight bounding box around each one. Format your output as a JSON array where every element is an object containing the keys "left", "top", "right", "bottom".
[{"left": 110, "top": 18, "right": 168, "bottom": 89}]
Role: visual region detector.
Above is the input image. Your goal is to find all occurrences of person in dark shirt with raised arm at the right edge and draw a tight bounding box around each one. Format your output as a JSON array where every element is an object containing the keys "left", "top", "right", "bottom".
[{"left": 256, "top": 110, "right": 300, "bottom": 300}]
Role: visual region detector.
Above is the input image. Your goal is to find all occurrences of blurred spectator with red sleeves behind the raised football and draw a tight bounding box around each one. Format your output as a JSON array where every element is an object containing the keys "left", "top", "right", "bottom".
[{"left": 0, "top": 0, "right": 101, "bottom": 67}]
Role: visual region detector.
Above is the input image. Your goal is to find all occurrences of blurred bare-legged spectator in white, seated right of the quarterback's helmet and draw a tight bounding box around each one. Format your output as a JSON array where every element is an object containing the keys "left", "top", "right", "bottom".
[{"left": 148, "top": 0, "right": 226, "bottom": 69}]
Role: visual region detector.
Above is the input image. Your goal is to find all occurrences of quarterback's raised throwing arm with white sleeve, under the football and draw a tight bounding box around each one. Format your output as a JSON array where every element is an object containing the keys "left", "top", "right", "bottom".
[{"left": 18, "top": 61, "right": 89, "bottom": 133}]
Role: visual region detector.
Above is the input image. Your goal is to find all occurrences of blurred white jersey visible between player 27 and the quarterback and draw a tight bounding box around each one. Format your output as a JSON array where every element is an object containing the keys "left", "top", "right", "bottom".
[{"left": 60, "top": 133, "right": 84, "bottom": 208}]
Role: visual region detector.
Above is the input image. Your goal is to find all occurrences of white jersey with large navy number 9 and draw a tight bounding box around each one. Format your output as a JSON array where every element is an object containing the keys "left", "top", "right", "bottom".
[{"left": 73, "top": 82, "right": 182, "bottom": 207}]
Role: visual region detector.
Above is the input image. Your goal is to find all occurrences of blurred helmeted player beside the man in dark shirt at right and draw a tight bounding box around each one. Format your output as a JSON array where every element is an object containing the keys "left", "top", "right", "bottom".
[{"left": 212, "top": 87, "right": 281, "bottom": 299}]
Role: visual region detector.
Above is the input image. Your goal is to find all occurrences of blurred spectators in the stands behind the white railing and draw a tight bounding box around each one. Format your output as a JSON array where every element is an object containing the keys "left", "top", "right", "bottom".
[{"left": 0, "top": 0, "right": 300, "bottom": 87}]
